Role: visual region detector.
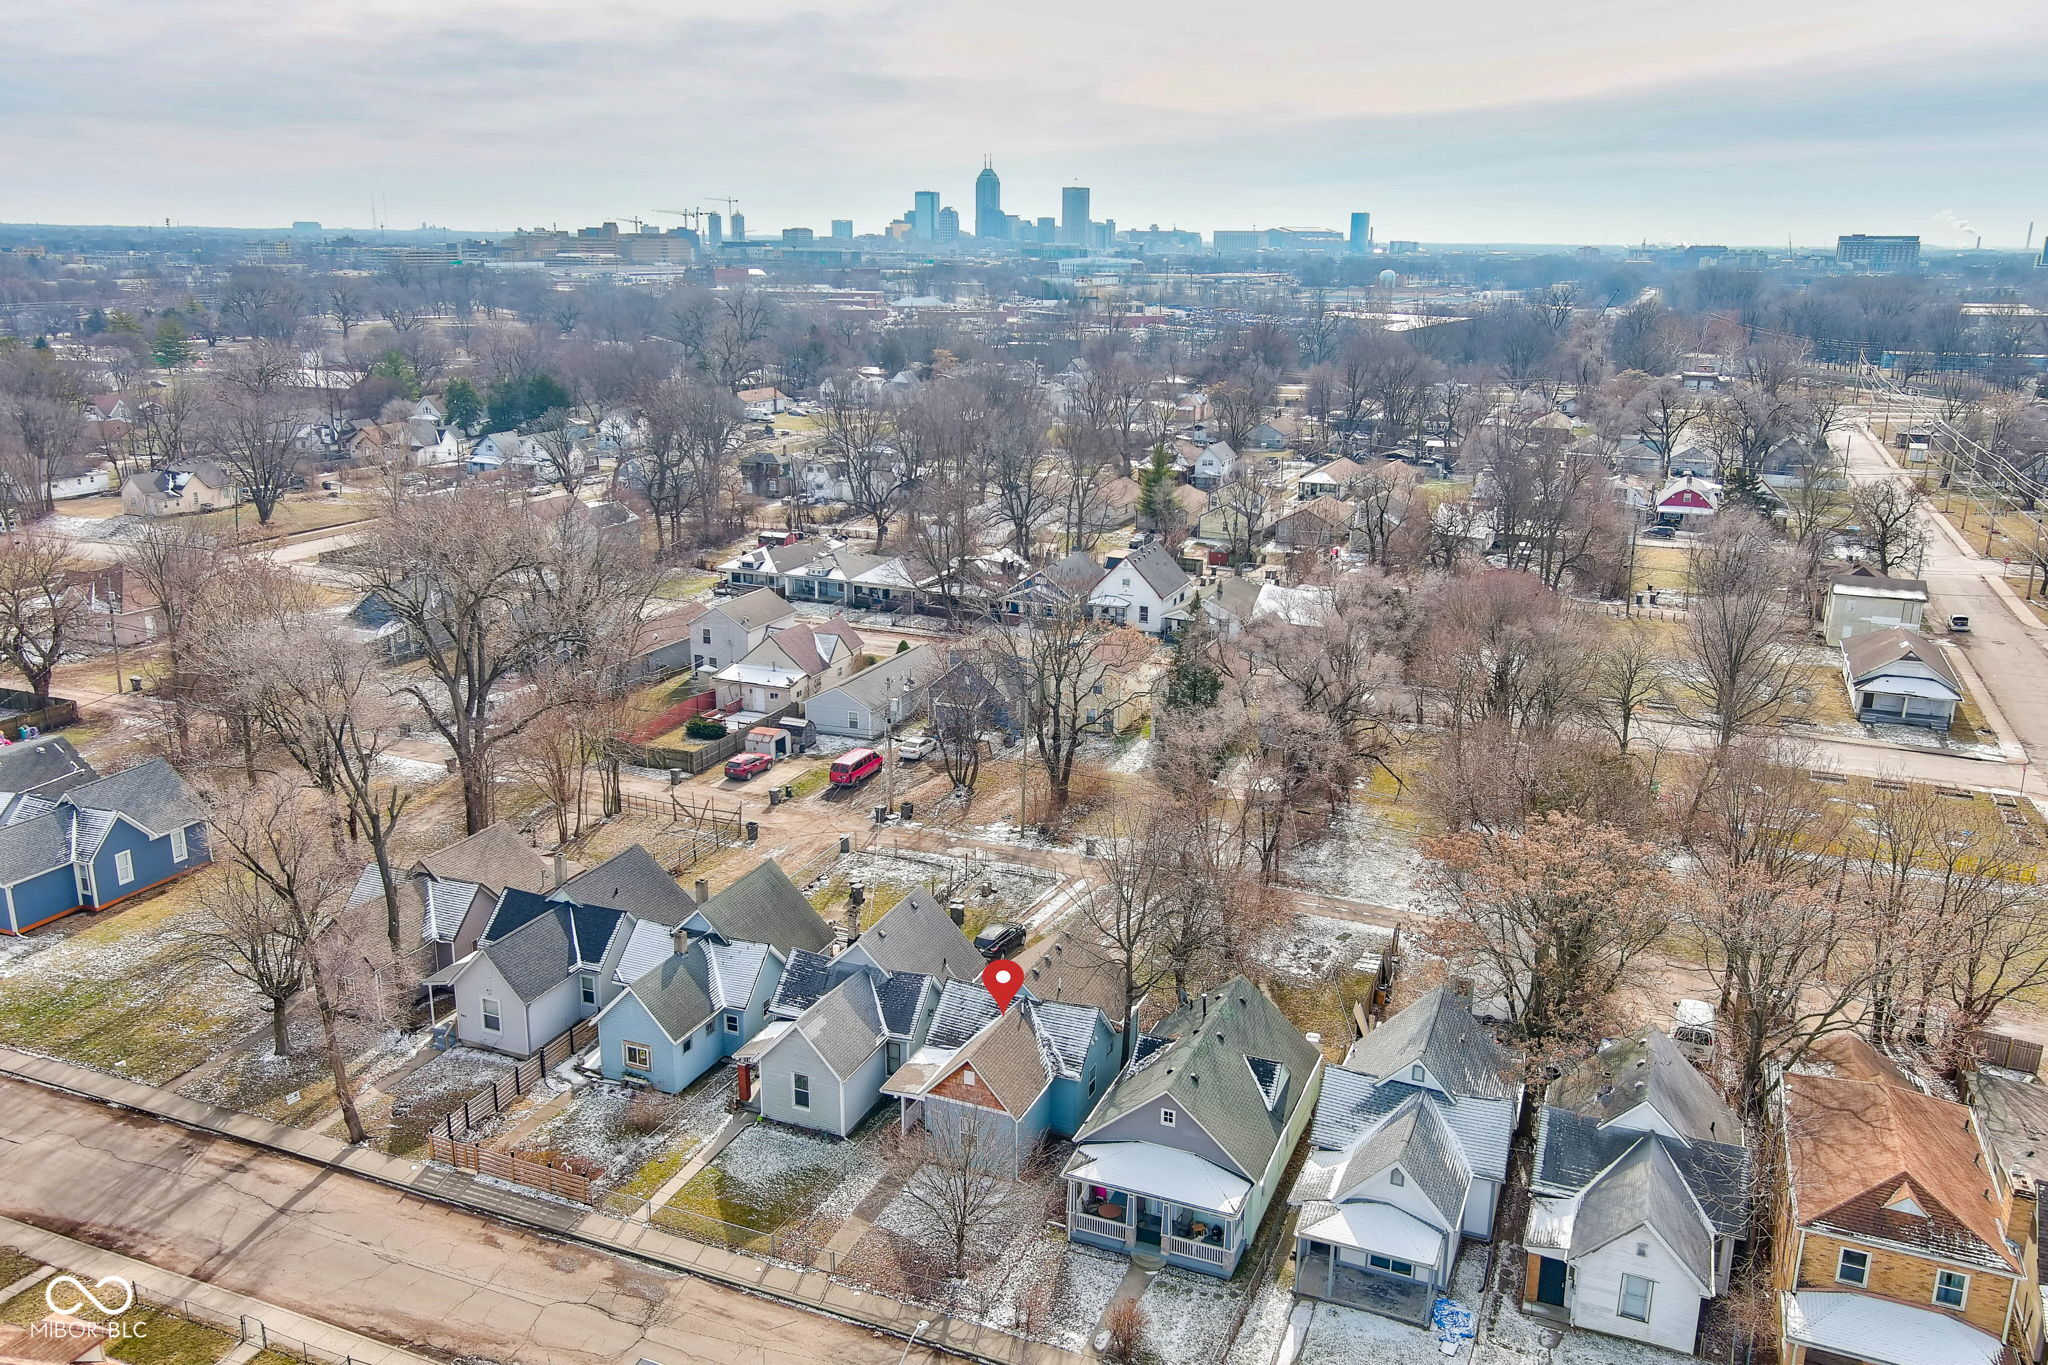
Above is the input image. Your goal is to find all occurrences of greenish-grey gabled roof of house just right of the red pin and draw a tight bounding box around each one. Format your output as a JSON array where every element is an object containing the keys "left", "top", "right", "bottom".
[{"left": 1075, "top": 976, "right": 1323, "bottom": 1181}]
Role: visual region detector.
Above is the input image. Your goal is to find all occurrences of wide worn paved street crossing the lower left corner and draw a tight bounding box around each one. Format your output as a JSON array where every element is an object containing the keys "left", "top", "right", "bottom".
[{"left": 0, "top": 1081, "right": 930, "bottom": 1365}]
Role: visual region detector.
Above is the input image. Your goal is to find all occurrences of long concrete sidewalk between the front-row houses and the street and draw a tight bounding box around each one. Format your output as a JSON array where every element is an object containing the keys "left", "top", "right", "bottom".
[{"left": 0, "top": 1048, "right": 1092, "bottom": 1365}]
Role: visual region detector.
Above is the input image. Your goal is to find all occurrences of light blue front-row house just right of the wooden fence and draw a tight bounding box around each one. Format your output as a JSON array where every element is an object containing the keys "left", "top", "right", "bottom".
[{"left": 598, "top": 862, "right": 831, "bottom": 1093}]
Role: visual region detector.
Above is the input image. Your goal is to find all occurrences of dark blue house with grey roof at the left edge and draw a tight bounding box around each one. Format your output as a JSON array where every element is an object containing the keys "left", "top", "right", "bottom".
[{"left": 0, "top": 745, "right": 211, "bottom": 933}]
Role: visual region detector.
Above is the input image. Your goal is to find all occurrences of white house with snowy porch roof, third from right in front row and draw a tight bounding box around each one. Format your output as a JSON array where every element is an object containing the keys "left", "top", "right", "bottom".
[{"left": 1288, "top": 986, "right": 1522, "bottom": 1322}]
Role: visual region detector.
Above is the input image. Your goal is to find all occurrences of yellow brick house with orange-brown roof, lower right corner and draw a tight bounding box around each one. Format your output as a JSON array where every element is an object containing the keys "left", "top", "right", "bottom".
[{"left": 1774, "top": 1036, "right": 2042, "bottom": 1365}]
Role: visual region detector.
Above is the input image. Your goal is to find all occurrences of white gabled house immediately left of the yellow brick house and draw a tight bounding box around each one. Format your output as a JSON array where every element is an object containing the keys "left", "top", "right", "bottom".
[{"left": 1522, "top": 1029, "right": 1749, "bottom": 1353}]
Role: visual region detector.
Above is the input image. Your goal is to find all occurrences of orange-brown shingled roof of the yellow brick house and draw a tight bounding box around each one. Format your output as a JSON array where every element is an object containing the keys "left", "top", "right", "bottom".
[{"left": 1782, "top": 1047, "right": 2019, "bottom": 1273}]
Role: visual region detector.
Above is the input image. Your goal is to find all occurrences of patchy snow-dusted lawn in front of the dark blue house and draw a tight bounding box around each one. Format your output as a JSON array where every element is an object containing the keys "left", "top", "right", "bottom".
[{"left": 0, "top": 868, "right": 262, "bottom": 1085}]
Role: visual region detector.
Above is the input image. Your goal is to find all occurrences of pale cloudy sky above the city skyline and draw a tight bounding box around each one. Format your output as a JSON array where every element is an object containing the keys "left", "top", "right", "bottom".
[{"left": 0, "top": 0, "right": 2048, "bottom": 248}]
